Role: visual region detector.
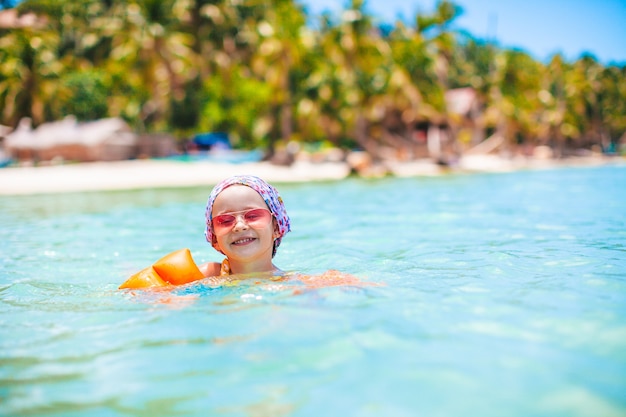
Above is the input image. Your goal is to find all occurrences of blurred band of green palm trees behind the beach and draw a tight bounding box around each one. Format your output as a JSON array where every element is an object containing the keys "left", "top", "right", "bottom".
[{"left": 0, "top": 0, "right": 626, "bottom": 152}]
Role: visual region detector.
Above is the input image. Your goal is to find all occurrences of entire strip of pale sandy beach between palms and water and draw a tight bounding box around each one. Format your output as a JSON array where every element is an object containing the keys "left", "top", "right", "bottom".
[{"left": 0, "top": 155, "right": 626, "bottom": 196}]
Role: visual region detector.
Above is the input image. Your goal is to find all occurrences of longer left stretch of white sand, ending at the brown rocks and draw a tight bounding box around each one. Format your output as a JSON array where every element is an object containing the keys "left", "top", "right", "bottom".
[{"left": 0, "top": 160, "right": 349, "bottom": 195}]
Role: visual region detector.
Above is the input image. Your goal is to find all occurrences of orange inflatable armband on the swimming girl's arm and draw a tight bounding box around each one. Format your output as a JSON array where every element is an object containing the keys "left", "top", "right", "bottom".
[{"left": 119, "top": 249, "right": 204, "bottom": 289}]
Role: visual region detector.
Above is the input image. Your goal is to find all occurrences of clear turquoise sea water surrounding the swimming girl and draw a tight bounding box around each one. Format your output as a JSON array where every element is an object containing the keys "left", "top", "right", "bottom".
[{"left": 0, "top": 166, "right": 626, "bottom": 417}]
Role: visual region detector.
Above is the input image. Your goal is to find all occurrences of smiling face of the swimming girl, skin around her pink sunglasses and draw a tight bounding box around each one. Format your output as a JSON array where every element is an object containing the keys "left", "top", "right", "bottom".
[{"left": 212, "top": 185, "right": 278, "bottom": 262}]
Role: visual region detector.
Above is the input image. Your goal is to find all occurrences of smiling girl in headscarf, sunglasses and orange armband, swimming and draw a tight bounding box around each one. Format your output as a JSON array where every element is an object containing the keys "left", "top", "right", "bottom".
[{"left": 120, "top": 175, "right": 362, "bottom": 288}]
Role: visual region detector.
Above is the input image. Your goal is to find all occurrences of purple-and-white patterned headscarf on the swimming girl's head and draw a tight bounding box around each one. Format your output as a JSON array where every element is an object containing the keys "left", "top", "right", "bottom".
[{"left": 204, "top": 175, "right": 291, "bottom": 257}]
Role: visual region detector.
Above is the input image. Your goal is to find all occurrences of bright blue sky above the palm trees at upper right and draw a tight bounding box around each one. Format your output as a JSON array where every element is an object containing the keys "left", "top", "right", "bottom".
[{"left": 299, "top": 0, "right": 626, "bottom": 64}]
